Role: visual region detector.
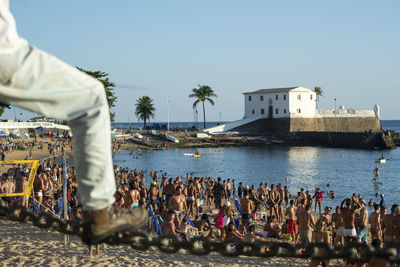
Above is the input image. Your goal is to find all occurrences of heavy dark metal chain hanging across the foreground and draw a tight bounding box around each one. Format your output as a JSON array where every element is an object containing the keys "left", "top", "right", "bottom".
[{"left": 0, "top": 200, "right": 400, "bottom": 264}]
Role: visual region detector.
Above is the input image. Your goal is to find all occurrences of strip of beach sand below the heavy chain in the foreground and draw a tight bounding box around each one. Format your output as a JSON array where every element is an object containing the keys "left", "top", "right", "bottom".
[{"left": 0, "top": 218, "right": 342, "bottom": 267}]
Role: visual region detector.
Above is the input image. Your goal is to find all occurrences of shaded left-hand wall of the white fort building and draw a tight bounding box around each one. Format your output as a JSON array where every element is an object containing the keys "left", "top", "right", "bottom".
[{"left": 243, "top": 92, "right": 289, "bottom": 118}]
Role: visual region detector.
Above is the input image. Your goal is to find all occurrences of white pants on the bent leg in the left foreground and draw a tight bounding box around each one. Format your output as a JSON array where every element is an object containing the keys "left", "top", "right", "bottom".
[{"left": 0, "top": 40, "right": 115, "bottom": 210}]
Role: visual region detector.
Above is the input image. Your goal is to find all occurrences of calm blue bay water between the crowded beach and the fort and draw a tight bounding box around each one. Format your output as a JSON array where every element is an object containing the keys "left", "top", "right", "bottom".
[{"left": 114, "top": 121, "right": 400, "bottom": 210}]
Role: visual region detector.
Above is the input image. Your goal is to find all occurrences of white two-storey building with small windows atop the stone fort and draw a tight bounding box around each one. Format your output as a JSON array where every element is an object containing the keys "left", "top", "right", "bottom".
[{"left": 243, "top": 87, "right": 317, "bottom": 119}]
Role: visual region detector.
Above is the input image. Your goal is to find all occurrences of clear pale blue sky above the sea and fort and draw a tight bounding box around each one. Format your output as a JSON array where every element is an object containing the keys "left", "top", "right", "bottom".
[{"left": 5, "top": 0, "right": 400, "bottom": 121}]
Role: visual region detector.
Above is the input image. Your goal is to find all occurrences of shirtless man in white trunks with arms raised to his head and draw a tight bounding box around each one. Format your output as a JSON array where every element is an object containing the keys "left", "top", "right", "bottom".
[{"left": 340, "top": 196, "right": 361, "bottom": 245}]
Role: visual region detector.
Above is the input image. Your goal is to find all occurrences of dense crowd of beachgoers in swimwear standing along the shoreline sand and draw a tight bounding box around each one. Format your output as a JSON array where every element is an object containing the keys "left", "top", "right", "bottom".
[{"left": 0, "top": 155, "right": 400, "bottom": 264}]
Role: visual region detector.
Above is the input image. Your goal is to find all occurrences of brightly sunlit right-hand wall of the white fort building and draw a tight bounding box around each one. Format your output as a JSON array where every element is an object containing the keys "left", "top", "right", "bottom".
[{"left": 289, "top": 87, "right": 317, "bottom": 118}]
